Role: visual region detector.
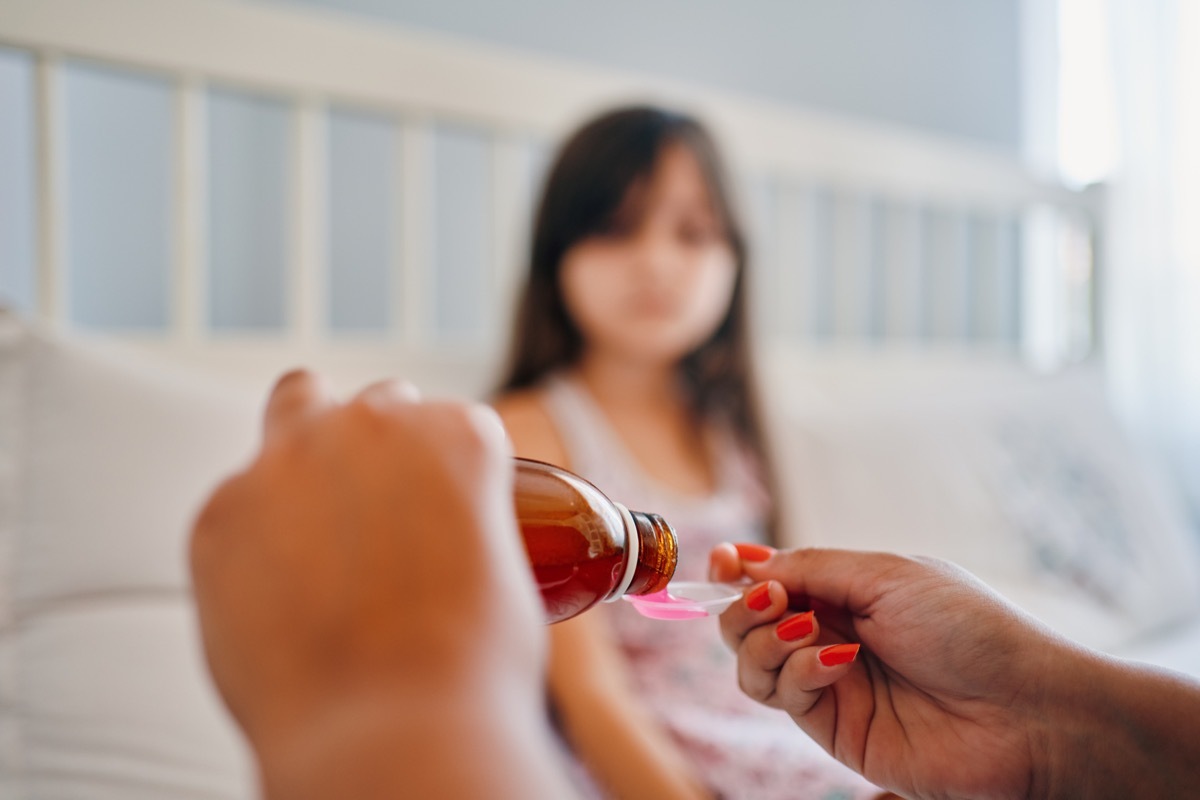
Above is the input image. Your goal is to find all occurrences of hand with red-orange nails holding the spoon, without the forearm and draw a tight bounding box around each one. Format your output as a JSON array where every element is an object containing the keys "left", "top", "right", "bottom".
[{"left": 712, "top": 545, "right": 1087, "bottom": 798}]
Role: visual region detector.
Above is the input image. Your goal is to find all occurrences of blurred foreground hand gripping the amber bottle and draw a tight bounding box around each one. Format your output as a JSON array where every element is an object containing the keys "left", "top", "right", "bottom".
[{"left": 191, "top": 372, "right": 552, "bottom": 796}]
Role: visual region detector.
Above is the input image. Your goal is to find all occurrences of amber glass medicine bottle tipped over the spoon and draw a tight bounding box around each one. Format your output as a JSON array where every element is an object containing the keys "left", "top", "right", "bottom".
[{"left": 515, "top": 458, "right": 679, "bottom": 622}]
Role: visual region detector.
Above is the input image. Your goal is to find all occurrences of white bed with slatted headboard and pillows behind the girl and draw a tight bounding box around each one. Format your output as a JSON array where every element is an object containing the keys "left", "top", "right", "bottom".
[{"left": 0, "top": 0, "right": 1200, "bottom": 800}]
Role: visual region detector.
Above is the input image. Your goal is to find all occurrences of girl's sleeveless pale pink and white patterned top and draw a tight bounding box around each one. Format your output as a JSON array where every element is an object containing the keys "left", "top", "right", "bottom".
[{"left": 542, "top": 374, "right": 878, "bottom": 800}]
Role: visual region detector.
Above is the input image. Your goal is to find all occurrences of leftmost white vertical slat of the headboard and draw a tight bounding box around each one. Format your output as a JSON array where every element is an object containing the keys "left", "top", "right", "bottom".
[{"left": 34, "top": 52, "right": 71, "bottom": 329}]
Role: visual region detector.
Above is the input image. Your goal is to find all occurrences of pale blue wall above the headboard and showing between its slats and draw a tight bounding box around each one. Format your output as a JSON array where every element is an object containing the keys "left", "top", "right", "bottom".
[{"left": 0, "top": 0, "right": 1019, "bottom": 331}]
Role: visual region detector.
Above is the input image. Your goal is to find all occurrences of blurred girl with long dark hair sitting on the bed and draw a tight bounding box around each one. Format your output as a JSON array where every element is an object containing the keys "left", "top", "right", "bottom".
[{"left": 496, "top": 108, "right": 878, "bottom": 800}]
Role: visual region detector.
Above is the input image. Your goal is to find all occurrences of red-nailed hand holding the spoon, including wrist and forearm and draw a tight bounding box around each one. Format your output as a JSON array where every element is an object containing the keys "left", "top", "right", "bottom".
[{"left": 712, "top": 546, "right": 1200, "bottom": 798}]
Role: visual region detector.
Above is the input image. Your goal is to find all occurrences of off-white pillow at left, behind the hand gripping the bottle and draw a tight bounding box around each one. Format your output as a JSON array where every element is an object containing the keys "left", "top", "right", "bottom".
[{"left": 0, "top": 311, "right": 259, "bottom": 800}]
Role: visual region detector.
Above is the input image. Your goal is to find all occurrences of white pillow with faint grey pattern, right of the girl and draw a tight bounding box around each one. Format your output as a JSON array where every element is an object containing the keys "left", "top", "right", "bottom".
[{"left": 768, "top": 354, "right": 1200, "bottom": 649}]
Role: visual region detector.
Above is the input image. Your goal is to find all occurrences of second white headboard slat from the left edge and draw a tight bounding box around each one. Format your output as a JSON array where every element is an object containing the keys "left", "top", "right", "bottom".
[{"left": 172, "top": 76, "right": 209, "bottom": 342}]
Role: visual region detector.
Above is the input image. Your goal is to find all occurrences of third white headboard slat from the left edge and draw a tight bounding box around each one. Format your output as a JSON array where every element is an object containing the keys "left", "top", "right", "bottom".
[{"left": 289, "top": 97, "right": 329, "bottom": 343}]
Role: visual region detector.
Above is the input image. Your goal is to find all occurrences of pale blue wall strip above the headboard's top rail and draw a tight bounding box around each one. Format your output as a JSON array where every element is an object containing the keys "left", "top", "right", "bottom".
[{"left": 255, "top": 0, "right": 1020, "bottom": 150}]
